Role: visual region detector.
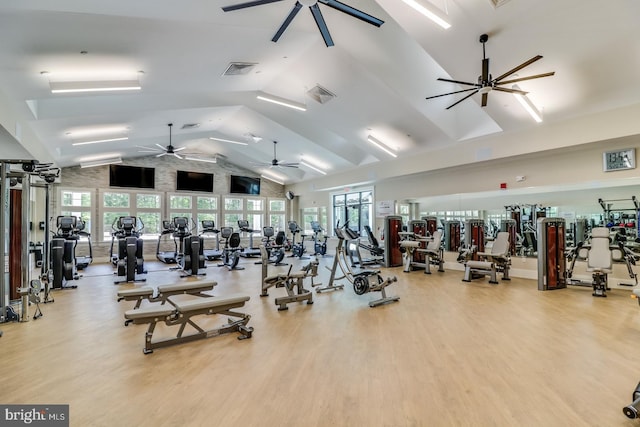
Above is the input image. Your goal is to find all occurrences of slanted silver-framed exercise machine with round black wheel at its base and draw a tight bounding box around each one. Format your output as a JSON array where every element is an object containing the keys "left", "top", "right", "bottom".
[{"left": 328, "top": 221, "right": 400, "bottom": 307}]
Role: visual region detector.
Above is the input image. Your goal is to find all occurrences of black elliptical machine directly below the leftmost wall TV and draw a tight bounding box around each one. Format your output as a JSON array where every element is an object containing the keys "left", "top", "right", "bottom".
[{"left": 111, "top": 216, "right": 147, "bottom": 285}]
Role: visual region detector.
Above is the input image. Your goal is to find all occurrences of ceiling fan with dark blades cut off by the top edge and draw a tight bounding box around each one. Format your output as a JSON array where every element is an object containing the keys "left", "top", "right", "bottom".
[{"left": 222, "top": 0, "right": 384, "bottom": 47}]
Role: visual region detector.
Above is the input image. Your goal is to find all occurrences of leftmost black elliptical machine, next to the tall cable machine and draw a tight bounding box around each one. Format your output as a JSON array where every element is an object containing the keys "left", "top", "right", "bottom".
[{"left": 51, "top": 215, "right": 80, "bottom": 289}]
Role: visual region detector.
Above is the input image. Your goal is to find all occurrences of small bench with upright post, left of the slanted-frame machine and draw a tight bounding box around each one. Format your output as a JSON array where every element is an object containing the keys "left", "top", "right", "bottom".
[{"left": 260, "top": 245, "right": 318, "bottom": 311}]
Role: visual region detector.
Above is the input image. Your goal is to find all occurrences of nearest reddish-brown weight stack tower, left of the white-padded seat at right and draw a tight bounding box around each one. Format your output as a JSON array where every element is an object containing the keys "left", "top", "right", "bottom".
[{"left": 537, "top": 218, "right": 567, "bottom": 291}]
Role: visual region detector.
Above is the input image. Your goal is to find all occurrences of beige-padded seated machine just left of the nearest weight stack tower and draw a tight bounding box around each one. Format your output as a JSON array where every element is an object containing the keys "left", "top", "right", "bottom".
[{"left": 462, "top": 231, "right": 511, "bottom": 284}]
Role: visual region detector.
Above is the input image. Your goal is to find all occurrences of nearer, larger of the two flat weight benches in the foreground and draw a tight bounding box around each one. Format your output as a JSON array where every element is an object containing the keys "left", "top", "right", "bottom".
[{"left": 124, "top": 295, "right": 253, "bottom": 354}]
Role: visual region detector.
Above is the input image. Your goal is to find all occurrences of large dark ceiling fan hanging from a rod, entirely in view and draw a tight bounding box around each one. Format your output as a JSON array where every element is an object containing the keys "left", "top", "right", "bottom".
[{"left": 426, "top": 34, "right": 555, "bottom": 110}]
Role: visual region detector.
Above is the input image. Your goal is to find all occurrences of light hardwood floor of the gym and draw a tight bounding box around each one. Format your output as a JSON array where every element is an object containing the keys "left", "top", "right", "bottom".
[{"left": 0, "top": 258, "right": 640, "bottom": 427}]
